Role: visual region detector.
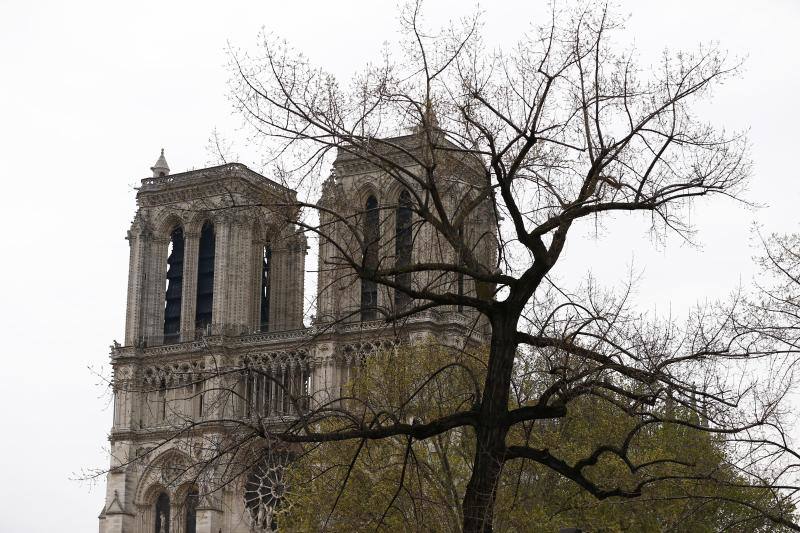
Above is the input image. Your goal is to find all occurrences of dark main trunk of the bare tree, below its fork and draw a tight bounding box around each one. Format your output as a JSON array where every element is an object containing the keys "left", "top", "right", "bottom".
[{"left": 463, "top": 323, "right": 516, "bottom": 533}]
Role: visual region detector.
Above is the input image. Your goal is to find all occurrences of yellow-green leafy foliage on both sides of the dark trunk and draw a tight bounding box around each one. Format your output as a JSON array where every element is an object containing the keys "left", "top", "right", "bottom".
[{"left": 279, "top": 344, "right": 787, "bottom": 532}]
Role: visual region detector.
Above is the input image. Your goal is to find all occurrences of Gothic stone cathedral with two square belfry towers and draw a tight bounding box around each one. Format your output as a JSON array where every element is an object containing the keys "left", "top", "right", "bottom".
[{"left": 99, "top": 134, "right": 497, "bottom": 533}]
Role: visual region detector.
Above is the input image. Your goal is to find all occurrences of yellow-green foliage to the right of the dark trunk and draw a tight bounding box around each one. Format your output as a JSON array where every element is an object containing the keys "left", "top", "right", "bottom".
[{"left": 495, "top": 397, "right": 787, "bottom": 532}]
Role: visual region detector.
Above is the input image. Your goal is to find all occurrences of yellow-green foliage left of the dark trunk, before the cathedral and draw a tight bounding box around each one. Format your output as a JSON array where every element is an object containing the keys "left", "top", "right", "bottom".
[{"left": 279, "top": 345, "right": 483, "bottom": 532}]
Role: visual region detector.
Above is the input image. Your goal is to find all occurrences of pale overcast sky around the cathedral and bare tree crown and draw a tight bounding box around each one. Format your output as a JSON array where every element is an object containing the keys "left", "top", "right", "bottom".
[{"left": 0, "top": 0, "right": 800, "bottom": 532}]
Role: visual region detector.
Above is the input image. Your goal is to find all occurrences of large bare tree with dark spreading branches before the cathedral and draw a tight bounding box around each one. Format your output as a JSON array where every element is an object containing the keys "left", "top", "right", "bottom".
[{"left": 95, "top": 3, "right": 800, "bottom": 532}]
